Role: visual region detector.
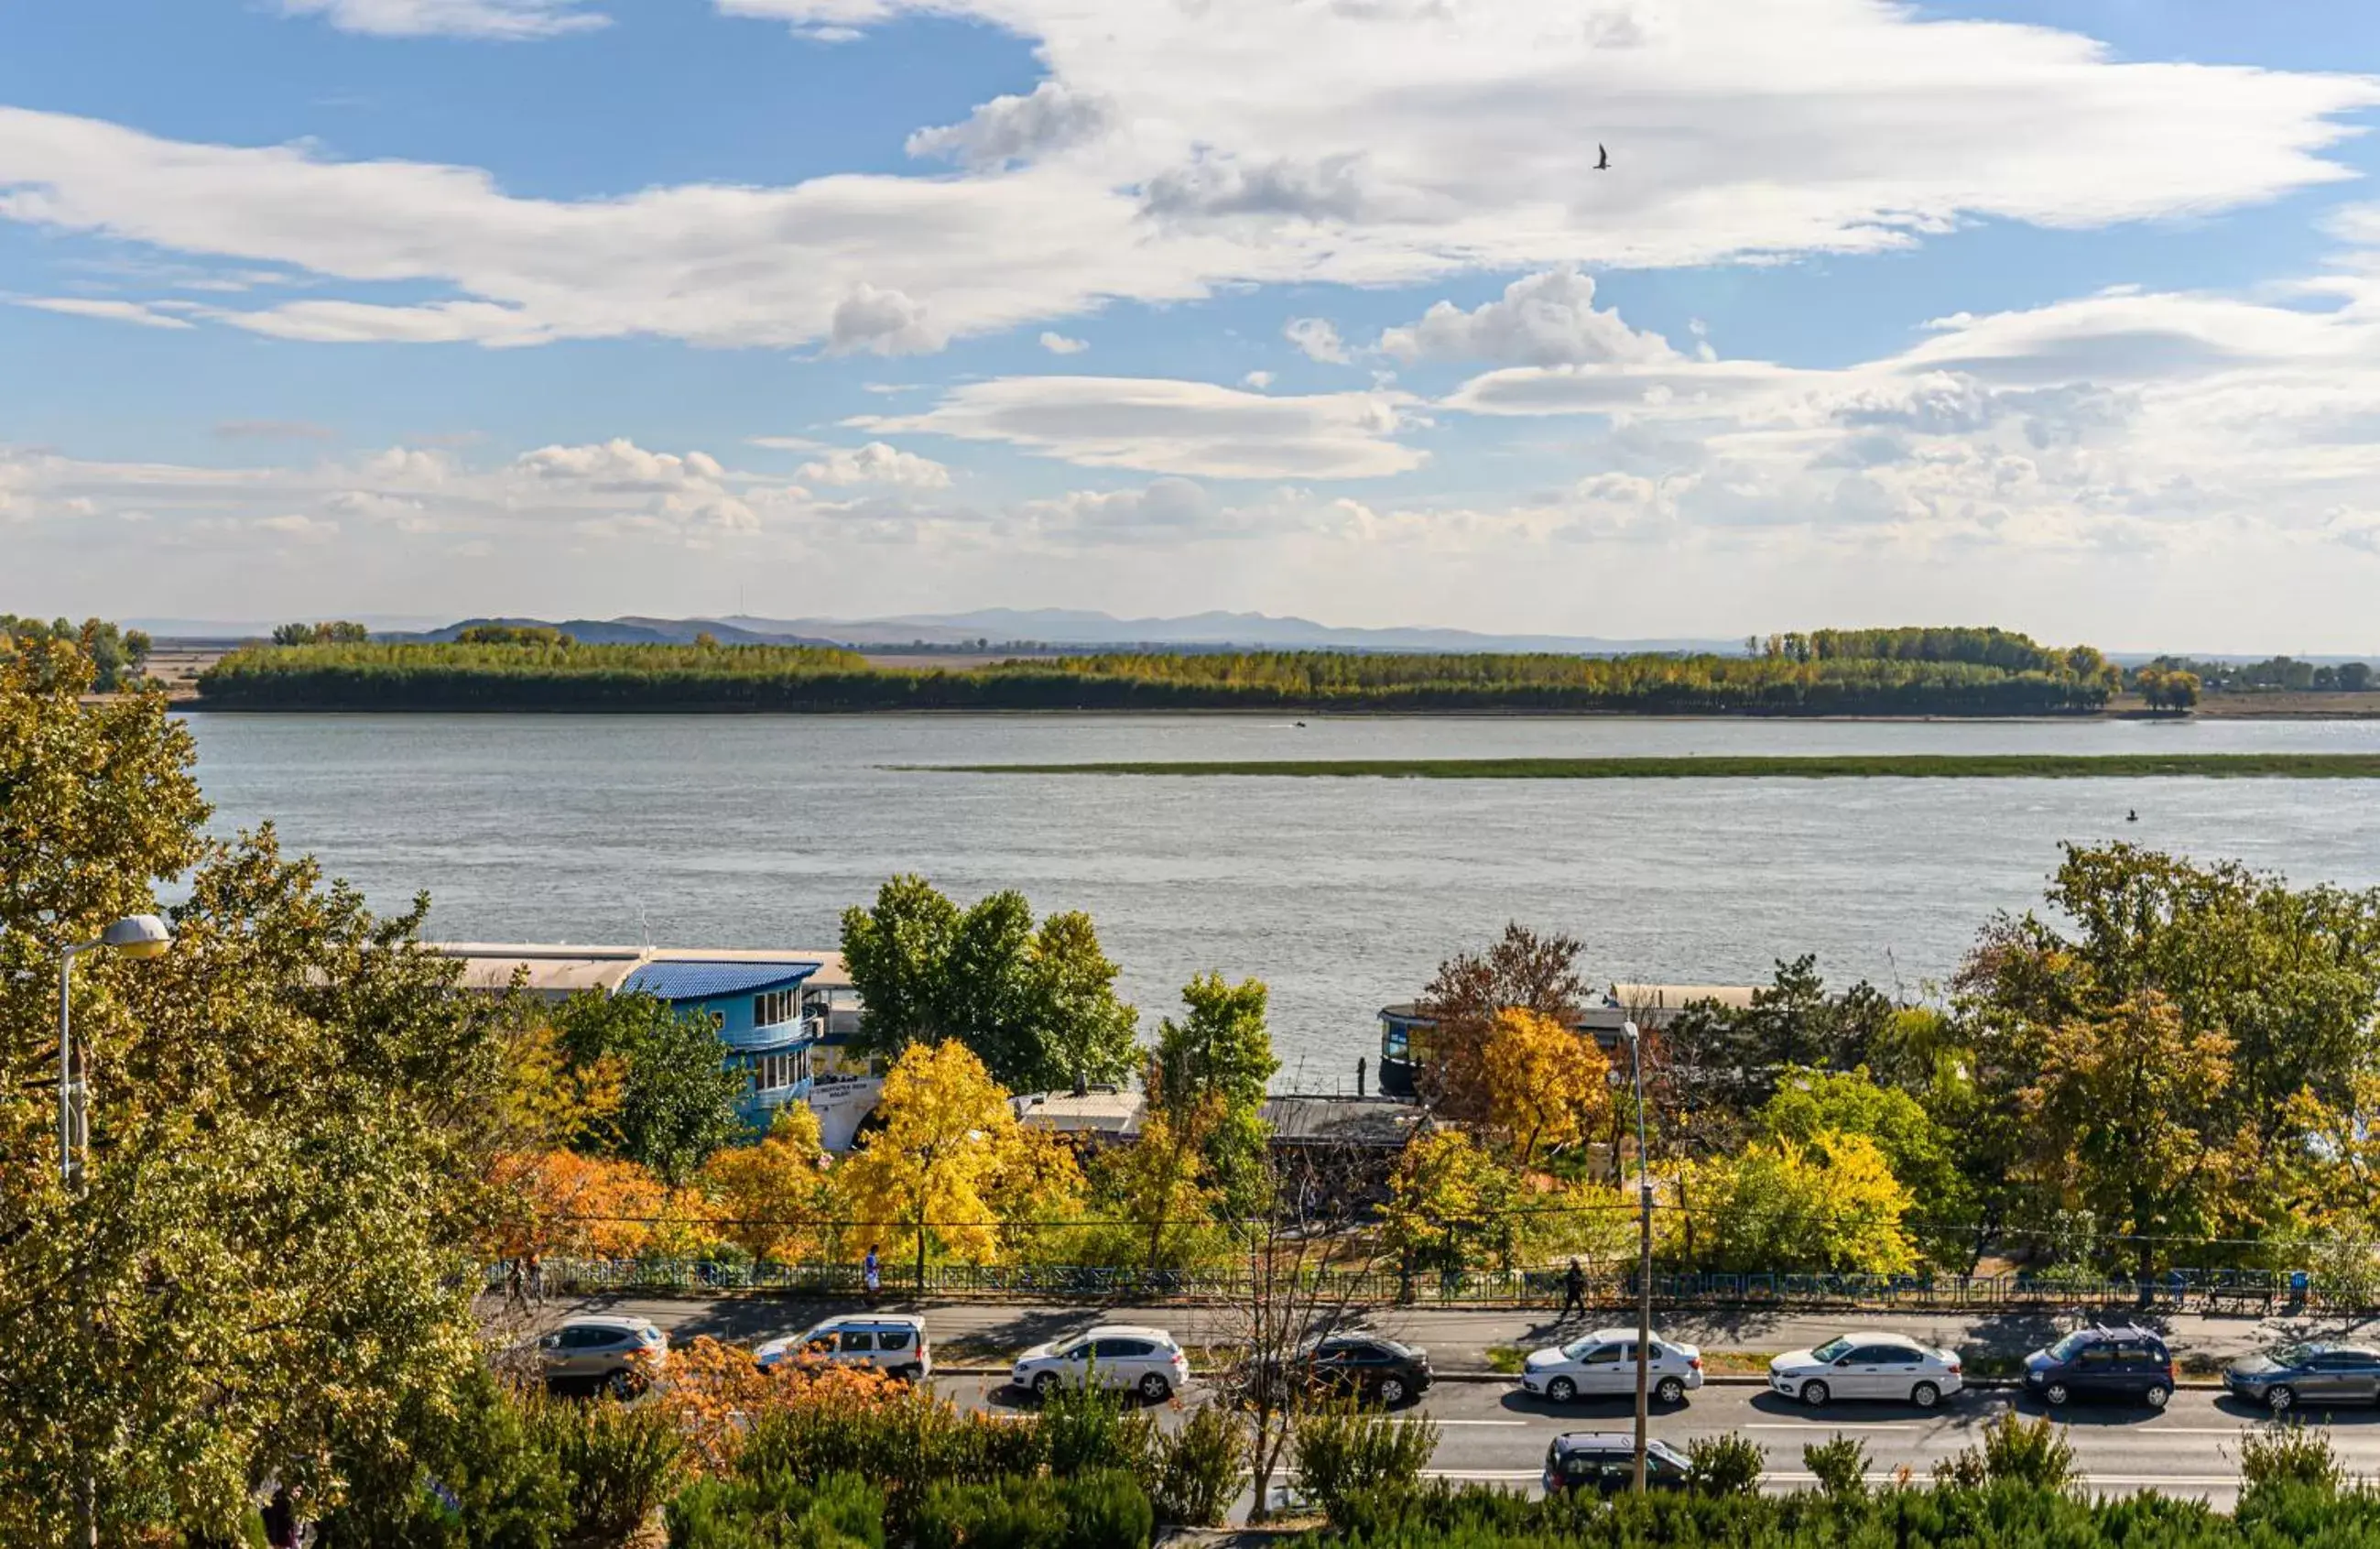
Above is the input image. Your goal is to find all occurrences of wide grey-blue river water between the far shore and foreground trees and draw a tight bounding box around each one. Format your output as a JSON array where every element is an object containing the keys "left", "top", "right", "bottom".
[{"left": 190, "top": 714, "right": 2380, "bottom": 1090}]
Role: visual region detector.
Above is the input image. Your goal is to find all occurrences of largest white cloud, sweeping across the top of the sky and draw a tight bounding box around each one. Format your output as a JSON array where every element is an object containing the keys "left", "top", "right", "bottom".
[{"left": 0, "top": 0, "right": 2380, "bottom": 352}]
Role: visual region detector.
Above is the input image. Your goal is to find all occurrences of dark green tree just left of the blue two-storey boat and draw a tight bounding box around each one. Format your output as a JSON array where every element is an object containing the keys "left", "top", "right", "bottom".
[{"left": 557, "top": 992, "right": 744, "bottom": 1185}]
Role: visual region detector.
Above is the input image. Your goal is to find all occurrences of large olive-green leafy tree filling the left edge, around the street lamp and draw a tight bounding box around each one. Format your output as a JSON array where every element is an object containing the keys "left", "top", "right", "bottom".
[{"left": 0, "top": 642, "right": 502, "bottom": 1546}]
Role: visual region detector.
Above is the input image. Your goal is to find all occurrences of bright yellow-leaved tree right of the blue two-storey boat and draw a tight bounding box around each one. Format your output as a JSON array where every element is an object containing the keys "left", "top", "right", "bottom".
[{"left": 833, "top": 1040, "right": 1081, "bottom": 1285}]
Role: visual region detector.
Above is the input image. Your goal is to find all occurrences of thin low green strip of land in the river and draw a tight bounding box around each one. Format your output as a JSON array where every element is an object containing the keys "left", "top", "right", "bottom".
[{"left": 897, "top": 752, "right": 2380, "bottom": 780}]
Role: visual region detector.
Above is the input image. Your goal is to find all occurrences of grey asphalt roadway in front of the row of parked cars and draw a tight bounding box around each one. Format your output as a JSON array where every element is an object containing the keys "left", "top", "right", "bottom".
[{"left": 935, "top": 1378, "right": 2380, "bottom": 1506}]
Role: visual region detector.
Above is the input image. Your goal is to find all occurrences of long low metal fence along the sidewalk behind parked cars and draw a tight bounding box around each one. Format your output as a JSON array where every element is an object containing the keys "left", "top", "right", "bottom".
[{"left": 502, "top": 1259, "right": 2342, "bottom": 1314}]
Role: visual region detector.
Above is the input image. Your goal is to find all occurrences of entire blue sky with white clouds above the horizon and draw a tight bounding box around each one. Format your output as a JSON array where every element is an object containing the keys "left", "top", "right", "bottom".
[{"left": 0, "top": 0, "right": 2380, "bottom": 654}]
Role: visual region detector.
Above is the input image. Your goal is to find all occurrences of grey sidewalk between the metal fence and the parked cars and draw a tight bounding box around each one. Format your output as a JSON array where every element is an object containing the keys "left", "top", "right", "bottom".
[{"left": 526, "top": 1294, "right": 2380, "bottom": 1373}]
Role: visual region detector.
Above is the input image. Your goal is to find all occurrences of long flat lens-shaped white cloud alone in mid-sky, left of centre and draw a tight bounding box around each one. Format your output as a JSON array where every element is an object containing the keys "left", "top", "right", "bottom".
[{"left": 847, "top": 376, "right": 1423, "bottom": 478}]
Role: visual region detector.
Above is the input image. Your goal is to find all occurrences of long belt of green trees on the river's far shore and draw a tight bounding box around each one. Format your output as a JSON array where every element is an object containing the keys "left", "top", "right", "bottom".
[{"left": 198, "top": 628, "right": 2118, "bottom": 716}]
